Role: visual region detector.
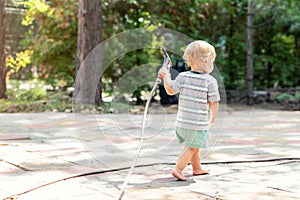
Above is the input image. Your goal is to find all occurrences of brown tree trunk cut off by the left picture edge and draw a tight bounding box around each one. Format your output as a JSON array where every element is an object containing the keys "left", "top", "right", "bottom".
[{"left": 0, "top": 0, "right": 6, "bottom": 99}]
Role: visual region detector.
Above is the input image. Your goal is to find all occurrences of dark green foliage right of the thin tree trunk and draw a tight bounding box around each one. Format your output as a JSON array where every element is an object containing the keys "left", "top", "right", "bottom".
[{"left": 254, "top": 1, "right": 300, "bottom": 89}]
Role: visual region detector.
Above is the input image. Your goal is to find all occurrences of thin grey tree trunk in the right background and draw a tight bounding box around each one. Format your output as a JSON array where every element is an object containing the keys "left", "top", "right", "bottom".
[{"left": 247, "top": 0, "right": 254, "bottom": 105}]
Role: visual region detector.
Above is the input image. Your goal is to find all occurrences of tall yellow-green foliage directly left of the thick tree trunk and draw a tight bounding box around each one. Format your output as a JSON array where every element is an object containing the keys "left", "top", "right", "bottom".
[{"left": 17, "top": 0, "right": 78, "bottom": 86}]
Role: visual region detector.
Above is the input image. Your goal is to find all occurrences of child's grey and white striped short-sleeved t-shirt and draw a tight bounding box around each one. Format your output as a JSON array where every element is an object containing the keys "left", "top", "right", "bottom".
[{"left": 171, "top": 71, "right": 220, "bottom": 130}]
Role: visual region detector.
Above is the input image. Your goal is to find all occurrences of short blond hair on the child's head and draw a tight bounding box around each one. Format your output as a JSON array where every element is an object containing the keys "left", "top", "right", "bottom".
[{"left": 183, "top": 40, "right": 216, "bottom": 68}]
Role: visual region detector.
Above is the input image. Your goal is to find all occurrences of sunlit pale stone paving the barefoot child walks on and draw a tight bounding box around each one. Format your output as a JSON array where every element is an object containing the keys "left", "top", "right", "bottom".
[{"left": 0, "top": 107, "right": 300, "bottom": 200}]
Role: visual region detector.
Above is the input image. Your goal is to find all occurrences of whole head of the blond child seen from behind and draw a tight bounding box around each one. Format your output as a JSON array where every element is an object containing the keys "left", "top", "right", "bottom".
[{"left": 183, "top": 40, "right": 216, "bottom": 73}]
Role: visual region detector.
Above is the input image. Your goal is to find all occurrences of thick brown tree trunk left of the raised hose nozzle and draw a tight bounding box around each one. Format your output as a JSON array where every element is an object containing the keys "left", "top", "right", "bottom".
[{"left": 74, "top": 0, "right": 102, "bottom": 105}]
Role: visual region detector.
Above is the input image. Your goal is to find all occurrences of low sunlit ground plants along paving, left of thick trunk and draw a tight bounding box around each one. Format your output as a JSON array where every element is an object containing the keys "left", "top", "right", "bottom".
[{"left": 0, "top": 80, "right": 72, "bottom": 113}]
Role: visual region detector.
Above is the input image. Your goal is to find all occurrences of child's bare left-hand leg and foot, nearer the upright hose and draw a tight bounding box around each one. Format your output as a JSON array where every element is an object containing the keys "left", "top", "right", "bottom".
[{"left": 172, "top": 147, "right": 197, "bottom": 181}]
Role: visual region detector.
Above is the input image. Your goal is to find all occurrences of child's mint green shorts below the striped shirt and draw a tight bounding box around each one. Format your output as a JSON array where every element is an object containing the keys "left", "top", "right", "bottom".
[{"left": 176, "top": 127, "right": 208, "bottom": 148}]
